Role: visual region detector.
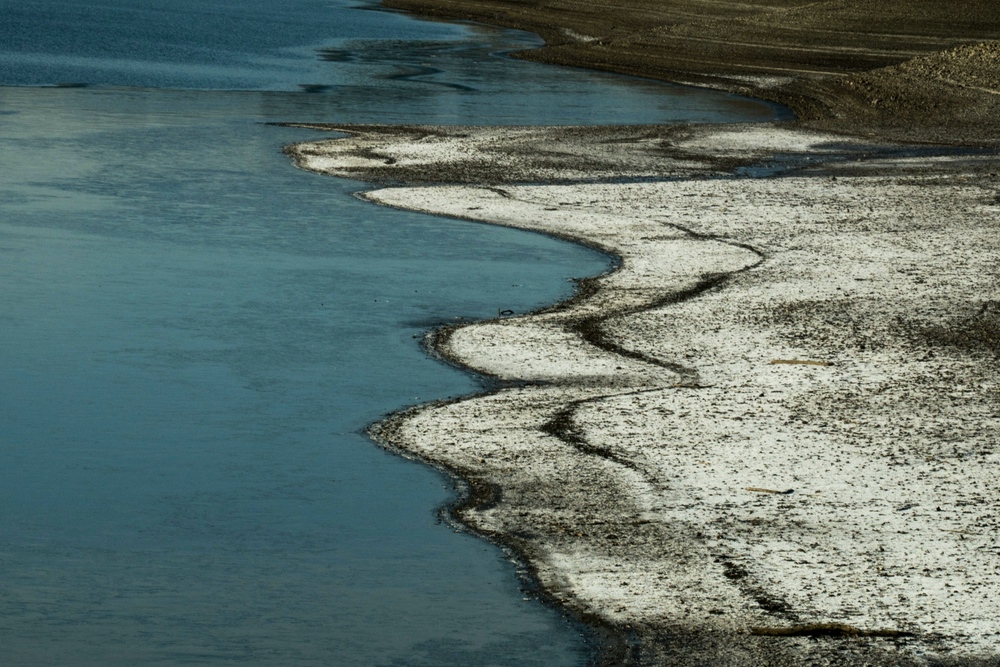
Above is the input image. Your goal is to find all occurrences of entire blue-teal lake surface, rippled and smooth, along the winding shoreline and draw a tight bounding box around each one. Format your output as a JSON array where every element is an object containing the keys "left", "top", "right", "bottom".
[{"left": 0, "top": 0, "right": 781, "bottom": 666}]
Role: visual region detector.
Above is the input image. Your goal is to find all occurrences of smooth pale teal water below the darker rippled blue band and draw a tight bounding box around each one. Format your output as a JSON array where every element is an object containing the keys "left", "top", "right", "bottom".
[{"left": 0, "top": 89, "right": 605, "bottom": 665}]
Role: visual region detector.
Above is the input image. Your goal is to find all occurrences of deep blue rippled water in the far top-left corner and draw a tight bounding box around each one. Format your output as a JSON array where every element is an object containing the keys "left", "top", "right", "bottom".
[{"left": 0, "top": 0, "right": 465, "bottom": 90}]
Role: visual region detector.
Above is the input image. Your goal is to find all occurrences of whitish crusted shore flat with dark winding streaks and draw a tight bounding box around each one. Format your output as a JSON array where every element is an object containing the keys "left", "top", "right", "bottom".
[{"left": 288, "top": 125, "right": 1000, "bottom": 666}]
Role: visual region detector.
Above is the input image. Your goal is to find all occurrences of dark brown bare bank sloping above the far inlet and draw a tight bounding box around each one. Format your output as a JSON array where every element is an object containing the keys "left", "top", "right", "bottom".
[{"left": 383, "top": 0, "right": 1000, "bottom": 145}]
